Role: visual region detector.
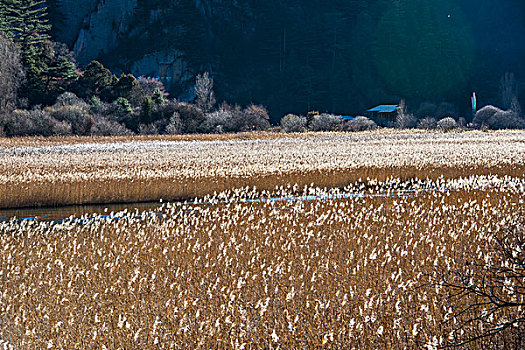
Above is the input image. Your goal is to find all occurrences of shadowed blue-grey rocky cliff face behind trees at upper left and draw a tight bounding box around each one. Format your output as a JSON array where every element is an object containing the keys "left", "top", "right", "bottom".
[{"left": 53, "top": 0, "right": 242, "bottom": 94}]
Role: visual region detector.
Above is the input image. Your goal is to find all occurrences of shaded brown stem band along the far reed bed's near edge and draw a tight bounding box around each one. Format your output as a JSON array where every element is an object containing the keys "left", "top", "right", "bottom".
[{"left": 0, "top": 166, "right": 525, "bottom": 209}]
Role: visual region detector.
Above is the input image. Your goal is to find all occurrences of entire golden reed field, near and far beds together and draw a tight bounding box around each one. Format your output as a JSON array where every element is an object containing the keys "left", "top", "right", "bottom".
[{"left": 0, "top": 131, "right": 525, "bottom": 349}]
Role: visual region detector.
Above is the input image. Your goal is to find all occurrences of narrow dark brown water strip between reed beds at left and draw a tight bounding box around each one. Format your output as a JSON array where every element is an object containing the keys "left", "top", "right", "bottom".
[{"left": 0, "top": 202, "right": 162, "bottom": 221}]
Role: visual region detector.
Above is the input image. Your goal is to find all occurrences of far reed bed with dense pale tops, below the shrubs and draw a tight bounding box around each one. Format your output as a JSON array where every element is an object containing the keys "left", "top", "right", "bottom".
[{"left": 0, "top": 131, "right": 525, "bottom": 208}]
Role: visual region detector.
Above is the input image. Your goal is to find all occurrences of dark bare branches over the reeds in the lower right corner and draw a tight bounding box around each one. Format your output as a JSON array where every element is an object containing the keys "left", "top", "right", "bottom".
[{"left": 441, "top": 219, "right": 525, "bottom": 349}]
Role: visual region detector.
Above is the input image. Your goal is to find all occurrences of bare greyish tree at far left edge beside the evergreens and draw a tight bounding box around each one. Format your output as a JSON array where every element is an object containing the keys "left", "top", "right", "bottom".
[{"left": 0, "top": 33, "right": 24, "bottom": 113}]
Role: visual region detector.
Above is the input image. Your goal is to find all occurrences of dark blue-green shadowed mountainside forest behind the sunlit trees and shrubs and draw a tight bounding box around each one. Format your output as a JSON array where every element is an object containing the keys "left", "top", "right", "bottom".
[{"left": 47, "top": 0, "right": 525, "bottom": 117}]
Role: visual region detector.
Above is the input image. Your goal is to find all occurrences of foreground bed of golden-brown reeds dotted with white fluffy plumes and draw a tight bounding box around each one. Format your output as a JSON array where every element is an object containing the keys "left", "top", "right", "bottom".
[{"left": 0, "top": 176, "right": 525, "bottom": 349}]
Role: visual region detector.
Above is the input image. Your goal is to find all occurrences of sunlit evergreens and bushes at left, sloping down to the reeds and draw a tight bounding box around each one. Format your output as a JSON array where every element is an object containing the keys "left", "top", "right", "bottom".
[{"left": 0, "top": 0, "right": 270, "bottom": 136}]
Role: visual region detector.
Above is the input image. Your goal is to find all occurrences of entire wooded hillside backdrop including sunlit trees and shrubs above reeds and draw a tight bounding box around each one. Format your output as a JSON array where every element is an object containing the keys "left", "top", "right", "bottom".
[{"left": 0, "top": 0, "right": 525, "bottom": 136}]
